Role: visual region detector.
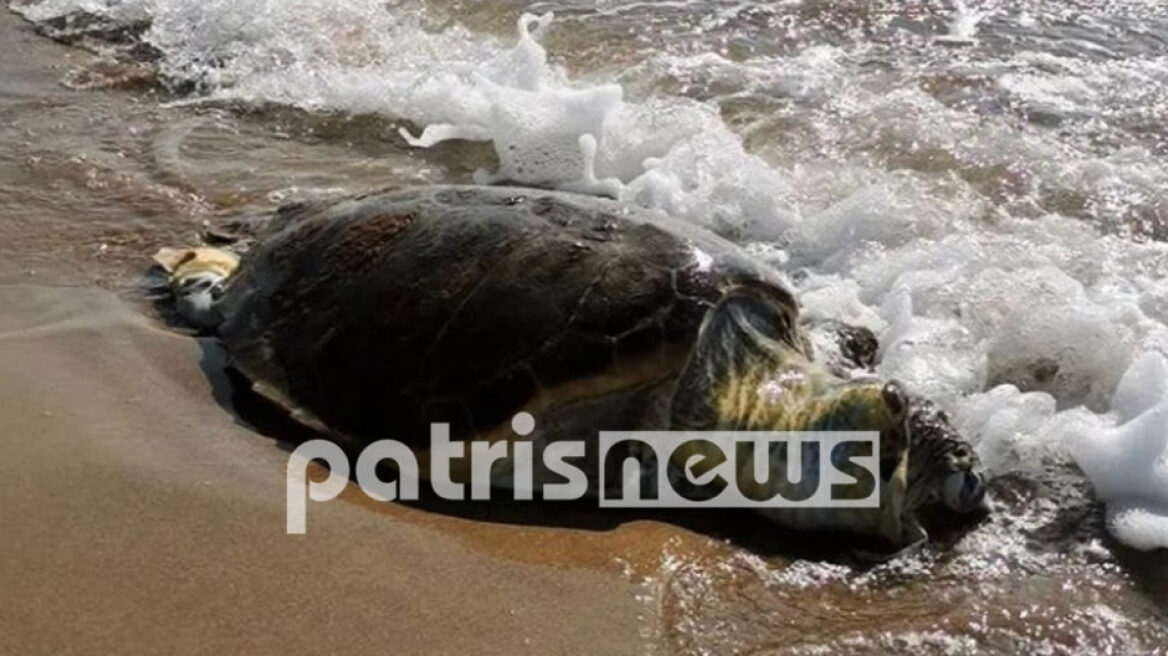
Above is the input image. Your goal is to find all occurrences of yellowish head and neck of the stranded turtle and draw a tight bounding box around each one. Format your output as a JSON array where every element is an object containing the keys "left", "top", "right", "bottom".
[{"left": 670, "top": 288, "right": 985, "bottom": 547}]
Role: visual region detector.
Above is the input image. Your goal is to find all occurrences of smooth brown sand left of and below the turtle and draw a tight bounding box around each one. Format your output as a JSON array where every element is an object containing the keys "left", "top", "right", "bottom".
[{"left": 0, "top": 12, "right": 644, "bottom": 655}]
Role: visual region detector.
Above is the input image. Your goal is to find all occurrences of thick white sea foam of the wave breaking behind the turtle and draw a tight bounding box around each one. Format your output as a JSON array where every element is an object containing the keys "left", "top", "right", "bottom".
[{"left": 15, "top": 0, "right": 1168, "bottom": 547}]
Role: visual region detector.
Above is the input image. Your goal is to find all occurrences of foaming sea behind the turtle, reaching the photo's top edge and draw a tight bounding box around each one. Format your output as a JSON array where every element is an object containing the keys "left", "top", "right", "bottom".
[{"left": 13, "top": 0, "right": 1168, "bottom": 647}]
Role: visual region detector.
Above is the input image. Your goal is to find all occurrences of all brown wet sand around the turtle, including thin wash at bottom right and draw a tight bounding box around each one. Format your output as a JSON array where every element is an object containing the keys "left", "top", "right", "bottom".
[{"left": 0, "top": 3, "right": 1168, "bottom": 655}]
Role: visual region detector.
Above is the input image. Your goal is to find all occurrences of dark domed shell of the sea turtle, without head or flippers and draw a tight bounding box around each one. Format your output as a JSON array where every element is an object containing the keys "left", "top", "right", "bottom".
[{"left": 220, "top": 187, "right": 794, "bottom": 445}]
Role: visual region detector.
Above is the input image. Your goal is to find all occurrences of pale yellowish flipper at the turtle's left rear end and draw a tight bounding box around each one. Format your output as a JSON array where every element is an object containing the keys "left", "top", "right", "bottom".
[{"left": 154, "top": 247, "right": 239, "bottom": 330}]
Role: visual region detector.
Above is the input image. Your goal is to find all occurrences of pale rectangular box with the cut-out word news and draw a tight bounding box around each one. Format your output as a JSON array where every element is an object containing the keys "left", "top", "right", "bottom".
[{"left": 598, "top": 431, "right": 880, "bottom": 508}]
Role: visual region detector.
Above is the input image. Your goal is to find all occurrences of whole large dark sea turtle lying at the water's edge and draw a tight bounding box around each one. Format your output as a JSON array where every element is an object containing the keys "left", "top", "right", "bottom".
[{"left": 150, "top": 186, "right": 983, "bottom": 547}]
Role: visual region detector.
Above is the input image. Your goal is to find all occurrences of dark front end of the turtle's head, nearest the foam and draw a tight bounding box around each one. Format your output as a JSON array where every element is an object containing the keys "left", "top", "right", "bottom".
[{"left": 909, "top": 398, "right": 986, "bottom": 515}]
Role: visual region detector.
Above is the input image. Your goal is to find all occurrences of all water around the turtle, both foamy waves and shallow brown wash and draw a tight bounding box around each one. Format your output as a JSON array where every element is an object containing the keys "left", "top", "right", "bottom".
[{"left": 0, "top": 0, "right": 1168, "bottom": 654}]
